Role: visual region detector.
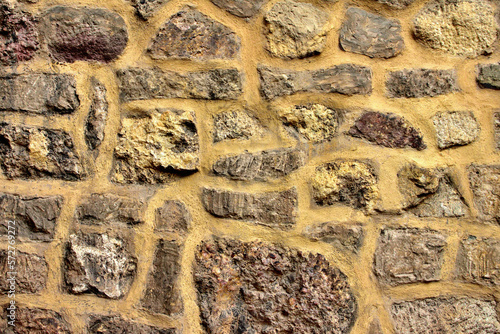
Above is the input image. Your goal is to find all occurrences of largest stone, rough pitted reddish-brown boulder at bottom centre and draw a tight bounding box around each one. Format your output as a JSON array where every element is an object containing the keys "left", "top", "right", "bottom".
[{"left": 194, "top": 238, "right": 356, "bottom": 334}]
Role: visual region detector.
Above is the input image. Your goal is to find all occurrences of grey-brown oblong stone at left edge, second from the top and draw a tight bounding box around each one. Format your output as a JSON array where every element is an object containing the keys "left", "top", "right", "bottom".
[{"left": 0, "top": 73, "right": 80, "bottom": 115}]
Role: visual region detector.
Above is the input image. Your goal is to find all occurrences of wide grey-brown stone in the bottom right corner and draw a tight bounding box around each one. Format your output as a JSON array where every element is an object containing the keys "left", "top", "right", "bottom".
[{"left": 391, "top": 297, "right": 500, "bottom": 334}]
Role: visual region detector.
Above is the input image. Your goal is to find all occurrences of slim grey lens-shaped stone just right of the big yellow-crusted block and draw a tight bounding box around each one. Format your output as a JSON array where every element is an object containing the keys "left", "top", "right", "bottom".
[{"left": 212, "top": 148, "right": 307, "bottom": 181}]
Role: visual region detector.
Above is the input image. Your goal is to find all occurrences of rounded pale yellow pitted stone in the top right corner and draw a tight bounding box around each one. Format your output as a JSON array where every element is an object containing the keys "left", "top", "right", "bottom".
[{"left": 413, "top": 0, "right": 498, "bottom": 57}]
